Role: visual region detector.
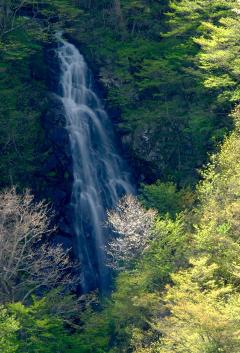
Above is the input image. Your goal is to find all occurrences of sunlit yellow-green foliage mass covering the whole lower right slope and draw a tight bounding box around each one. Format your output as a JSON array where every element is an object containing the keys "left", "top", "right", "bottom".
[{"left": 83, "top": 109, "right": 240, "bottom": 353}]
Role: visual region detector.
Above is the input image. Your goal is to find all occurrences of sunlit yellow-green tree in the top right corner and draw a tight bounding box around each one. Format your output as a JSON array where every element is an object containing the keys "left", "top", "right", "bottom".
[{"left": 196, "top": 1, "right": 240, "bottom": 102}]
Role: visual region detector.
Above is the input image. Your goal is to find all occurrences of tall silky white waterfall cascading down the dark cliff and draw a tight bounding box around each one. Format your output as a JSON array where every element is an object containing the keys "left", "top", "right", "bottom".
[{"left": 57, "top": 35, "right": 133, "bottom": 291}]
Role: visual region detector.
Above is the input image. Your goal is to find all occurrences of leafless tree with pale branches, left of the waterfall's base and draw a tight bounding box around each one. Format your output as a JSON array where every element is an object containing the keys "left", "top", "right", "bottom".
[{"left": 0, "top": 188, "right": 76, "bottom": 302}]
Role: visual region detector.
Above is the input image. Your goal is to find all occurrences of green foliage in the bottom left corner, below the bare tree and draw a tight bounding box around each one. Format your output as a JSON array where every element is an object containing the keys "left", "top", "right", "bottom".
[{"left": 0, "top": 290, "right": 88, "bottom": 353}]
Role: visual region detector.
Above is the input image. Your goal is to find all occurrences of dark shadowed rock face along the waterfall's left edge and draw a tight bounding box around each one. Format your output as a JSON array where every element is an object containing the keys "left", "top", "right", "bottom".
[{"left": 41, "top": 45, "right": 74, "bottom": 250}]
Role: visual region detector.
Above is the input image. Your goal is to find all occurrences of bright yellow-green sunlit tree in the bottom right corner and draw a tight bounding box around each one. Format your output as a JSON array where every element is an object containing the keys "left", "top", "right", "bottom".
[{"left": 143, "top": 257, "right": 240, "bottom": 353}]
